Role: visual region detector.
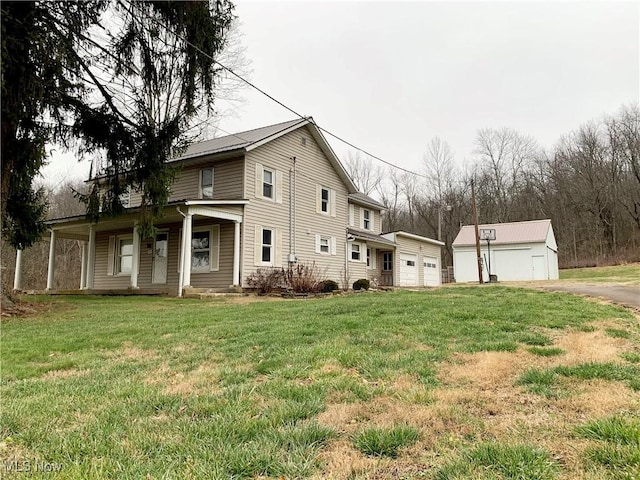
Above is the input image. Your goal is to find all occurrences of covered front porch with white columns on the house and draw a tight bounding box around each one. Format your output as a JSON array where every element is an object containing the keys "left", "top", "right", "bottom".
[{"left": 14, "top": 200, "right": 246, "bottom": 296}]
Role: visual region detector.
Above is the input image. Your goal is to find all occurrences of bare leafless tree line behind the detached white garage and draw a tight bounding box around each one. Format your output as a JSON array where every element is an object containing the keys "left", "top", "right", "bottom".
[{"left": 344, "top": 105, "right": 640, "bottom": 267}]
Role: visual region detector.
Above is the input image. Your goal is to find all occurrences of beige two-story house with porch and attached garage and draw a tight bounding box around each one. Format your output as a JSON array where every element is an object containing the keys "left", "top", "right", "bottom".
[{"left": 27, "top": 118, "right": 443, "bottom": 295}]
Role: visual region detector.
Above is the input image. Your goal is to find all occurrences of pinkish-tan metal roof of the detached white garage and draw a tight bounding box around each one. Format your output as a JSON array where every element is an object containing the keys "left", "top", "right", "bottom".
[{"left": 453, "top": 219, "right": 551, "bottom": 247}]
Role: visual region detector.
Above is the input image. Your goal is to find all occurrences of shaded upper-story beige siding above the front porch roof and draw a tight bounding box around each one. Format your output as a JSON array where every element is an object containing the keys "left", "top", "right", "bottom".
[{"left": 125, "top": 158, "right": 244, "bottom": 207}]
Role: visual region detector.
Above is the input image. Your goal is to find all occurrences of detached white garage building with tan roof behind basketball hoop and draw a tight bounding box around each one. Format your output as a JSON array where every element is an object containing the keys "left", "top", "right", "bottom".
[{"left": 453, "top": 220, "right": 558, "bottom": 282}]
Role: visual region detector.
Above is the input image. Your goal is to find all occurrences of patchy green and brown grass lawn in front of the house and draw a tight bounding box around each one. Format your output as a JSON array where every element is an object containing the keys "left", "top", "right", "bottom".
[{"left": 0, "top": 286, "right": 640, "bottom": 480}]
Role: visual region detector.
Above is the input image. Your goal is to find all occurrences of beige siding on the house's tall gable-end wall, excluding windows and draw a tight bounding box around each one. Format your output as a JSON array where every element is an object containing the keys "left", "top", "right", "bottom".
[{"left": 242, "top": 127, "right": 348, "bottom": 285}]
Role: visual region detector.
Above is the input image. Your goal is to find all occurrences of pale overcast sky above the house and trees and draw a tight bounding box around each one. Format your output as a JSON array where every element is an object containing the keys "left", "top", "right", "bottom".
[{"left": 44, "top": 0, "right": 640, "bottom": 185}]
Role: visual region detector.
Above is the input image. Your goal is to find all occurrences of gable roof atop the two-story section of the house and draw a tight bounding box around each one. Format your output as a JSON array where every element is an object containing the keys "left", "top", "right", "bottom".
[{"left": 170, "top": 117, "right": 358, "bottom": 193}]
